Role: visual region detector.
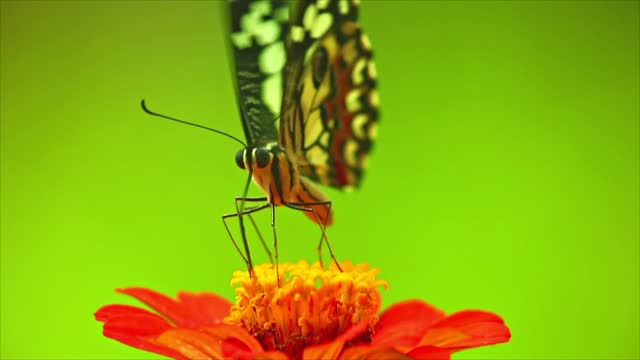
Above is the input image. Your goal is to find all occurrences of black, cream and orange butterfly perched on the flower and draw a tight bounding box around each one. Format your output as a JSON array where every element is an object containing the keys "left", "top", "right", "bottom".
[{"left": 223, "top": 0, "right": 378, "bottom": 269}]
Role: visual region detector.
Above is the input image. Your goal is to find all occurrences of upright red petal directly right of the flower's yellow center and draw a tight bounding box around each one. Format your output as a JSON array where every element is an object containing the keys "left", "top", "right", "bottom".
[{"left": 371, "top": 300, "right": 445, "bottom": 351}]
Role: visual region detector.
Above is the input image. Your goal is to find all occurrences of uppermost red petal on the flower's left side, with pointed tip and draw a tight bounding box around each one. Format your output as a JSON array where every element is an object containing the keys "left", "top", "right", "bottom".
[{"left": 117, "top": 287, "right": 231, "bottom": 328}]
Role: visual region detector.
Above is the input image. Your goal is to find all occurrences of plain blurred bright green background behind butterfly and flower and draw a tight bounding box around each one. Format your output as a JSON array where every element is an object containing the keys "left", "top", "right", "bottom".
[{"left": 0, "top": 1, "right": 640, "bottom": 359}]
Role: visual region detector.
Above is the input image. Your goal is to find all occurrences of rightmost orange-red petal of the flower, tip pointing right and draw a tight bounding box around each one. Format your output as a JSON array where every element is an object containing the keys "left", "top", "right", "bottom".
[{"left": 420, "top": 310, "right": 511, "bottom": 351}]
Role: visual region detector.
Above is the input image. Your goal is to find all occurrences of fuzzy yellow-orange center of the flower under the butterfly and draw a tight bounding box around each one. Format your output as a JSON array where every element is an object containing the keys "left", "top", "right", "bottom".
[{"left": 225, "top": 261, "right": 388, "bottom": 358}]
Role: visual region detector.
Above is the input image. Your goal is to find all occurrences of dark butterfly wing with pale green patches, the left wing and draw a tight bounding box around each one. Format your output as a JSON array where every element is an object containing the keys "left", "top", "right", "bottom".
[{"left": 227, "top": 0, "right": 289, "bottom": 146}]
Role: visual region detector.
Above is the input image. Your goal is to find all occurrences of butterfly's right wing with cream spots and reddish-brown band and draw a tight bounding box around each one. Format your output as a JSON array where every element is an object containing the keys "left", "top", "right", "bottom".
[{"left": 279, "top": 0, "right": 378, "bottom": 188}]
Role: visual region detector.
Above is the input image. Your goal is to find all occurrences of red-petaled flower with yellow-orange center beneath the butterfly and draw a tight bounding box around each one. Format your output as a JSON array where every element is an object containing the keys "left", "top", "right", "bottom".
[{"left": 95, "top": 262, "right": 511, "bottom": 359}]
